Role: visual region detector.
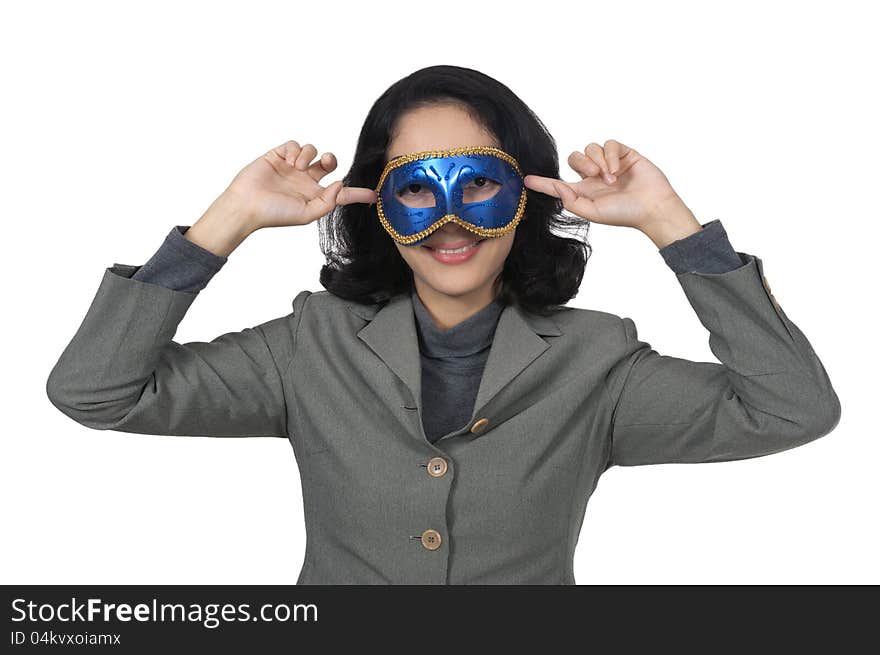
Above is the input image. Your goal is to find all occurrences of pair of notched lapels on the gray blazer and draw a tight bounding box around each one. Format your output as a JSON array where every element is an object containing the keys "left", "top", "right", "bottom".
[{"left": 349, "top": 293, "right": 562, "bottom": 426}]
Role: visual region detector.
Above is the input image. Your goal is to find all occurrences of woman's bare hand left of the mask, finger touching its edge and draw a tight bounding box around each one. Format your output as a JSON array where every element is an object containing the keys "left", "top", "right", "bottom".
[{"left": 185, "top": 141, "right": 376, "bottom": 257}]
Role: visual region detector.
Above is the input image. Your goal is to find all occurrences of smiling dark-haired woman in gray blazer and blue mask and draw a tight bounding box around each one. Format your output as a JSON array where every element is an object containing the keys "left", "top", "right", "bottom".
[{"left": 47, "top": 66, "right": 840, "bottom": 584}]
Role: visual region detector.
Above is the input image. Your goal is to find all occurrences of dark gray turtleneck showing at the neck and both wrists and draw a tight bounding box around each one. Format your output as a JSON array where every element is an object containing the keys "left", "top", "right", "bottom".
[{"left": 124, "top": 219, "right": 743, "bottom": 443}]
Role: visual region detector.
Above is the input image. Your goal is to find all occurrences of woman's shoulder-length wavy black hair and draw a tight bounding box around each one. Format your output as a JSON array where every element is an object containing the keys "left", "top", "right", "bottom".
[{"left": 319, "top": 65, "right": 592, "bottom": 315}]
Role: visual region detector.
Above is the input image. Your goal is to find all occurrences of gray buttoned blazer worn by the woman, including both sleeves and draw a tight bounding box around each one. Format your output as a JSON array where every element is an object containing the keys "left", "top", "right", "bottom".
[{"left": 46, "top": 253, "right": 840, "bottom": 584}]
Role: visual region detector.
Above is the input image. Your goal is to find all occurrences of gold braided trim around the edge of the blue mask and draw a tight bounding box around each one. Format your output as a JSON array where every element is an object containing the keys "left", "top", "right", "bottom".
[{"left": 375, "top": 146, "right": 526, "bottom": 245}]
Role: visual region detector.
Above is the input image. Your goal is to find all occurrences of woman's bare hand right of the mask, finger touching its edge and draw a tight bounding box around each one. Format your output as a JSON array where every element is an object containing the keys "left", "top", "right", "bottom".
[{"left": 524, "top": 139, "right": 701, "bottom": 247}]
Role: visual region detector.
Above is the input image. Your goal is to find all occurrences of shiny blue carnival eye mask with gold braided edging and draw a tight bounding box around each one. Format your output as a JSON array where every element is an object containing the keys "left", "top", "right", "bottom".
[{"left": 376, "top": 146, "right": 526, "bottom": 246}]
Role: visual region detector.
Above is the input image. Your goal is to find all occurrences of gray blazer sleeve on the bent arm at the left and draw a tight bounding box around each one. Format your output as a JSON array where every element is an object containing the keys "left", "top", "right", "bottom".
[{"left": 46, "top": 264, "right": 311, "bottom": 437}]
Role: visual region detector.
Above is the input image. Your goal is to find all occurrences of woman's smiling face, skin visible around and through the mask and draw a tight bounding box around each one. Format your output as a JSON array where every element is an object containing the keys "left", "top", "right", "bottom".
[{"left": 386, "top": 105, "right": 516, "bottom": 304}]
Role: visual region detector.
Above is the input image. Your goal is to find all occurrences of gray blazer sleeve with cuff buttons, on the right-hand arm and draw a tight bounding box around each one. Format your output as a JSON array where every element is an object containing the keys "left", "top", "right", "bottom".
[{"left": 607, "top": 253, "right": 841, "bottom": 467}]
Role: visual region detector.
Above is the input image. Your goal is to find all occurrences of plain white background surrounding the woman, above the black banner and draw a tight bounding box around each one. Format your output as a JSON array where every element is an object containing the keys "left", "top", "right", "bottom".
[{"left": 0, "top": 1, "right": 880, "bottom": 584}]
